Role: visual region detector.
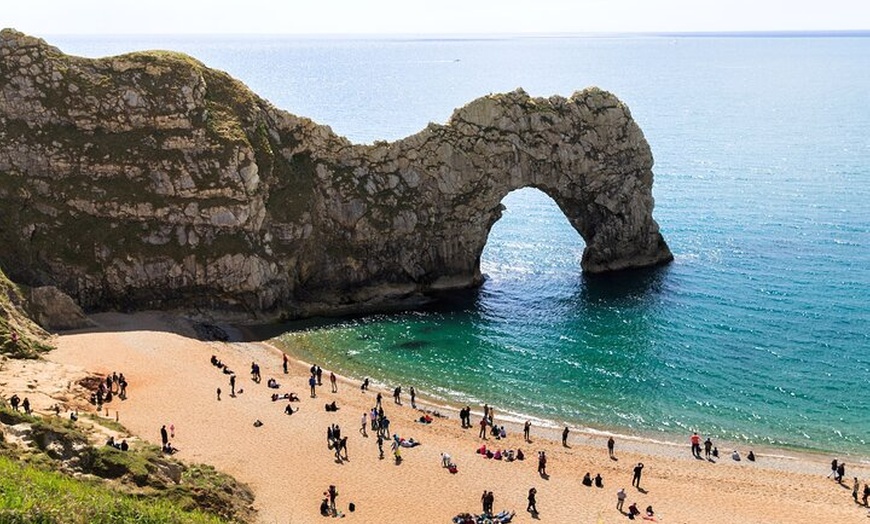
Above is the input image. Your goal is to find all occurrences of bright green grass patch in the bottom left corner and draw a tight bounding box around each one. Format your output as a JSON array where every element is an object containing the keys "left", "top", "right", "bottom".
[{"left": 0, "top": 456, "right": 222, "bottom": 524}]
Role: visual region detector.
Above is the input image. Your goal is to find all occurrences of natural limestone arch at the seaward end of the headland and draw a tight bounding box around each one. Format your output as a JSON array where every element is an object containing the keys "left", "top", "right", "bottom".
[{"left": 378, "top": 88, "right": 673, "bottom": 288}]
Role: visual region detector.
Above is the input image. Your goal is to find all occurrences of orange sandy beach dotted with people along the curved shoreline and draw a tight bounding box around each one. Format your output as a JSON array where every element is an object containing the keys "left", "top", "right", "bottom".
[{"left": 0, "top": 312, "right": 870, "bottom": 524}]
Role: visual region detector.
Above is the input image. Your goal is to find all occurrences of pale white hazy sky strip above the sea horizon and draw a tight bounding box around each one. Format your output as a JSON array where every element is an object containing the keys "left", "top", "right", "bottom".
[{"left": 6, "top": 0, "right": 870, "bottom": 36}]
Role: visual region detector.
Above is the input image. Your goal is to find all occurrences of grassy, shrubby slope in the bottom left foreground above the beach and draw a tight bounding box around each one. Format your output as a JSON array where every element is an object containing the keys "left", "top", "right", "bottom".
[{"left": 0, "top": 407, "right": 254, "bottom": 523}]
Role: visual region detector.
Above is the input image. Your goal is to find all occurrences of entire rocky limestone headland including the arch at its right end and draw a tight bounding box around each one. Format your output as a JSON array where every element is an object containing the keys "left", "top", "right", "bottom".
[{"left": 0, "top": 30, "right": 672, "bottom": 314}]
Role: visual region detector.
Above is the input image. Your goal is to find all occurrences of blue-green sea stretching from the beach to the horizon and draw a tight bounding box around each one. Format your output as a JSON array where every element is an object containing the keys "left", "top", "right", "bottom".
[{"left": 56, "top": 32, "right": 870, "bottom": 460}]
